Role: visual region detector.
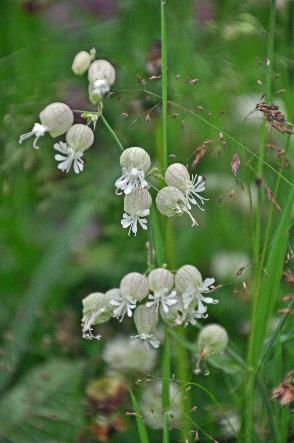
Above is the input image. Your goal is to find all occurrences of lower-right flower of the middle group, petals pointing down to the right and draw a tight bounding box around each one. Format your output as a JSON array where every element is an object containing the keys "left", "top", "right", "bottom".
[{"left": 155, "top": 186, "right": 198, "bottom": 227}]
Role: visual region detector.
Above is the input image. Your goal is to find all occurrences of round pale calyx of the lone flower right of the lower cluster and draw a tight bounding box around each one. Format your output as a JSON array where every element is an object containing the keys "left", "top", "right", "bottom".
[{"left": 198, "top": 324, "right": 229, "bottom": 354}]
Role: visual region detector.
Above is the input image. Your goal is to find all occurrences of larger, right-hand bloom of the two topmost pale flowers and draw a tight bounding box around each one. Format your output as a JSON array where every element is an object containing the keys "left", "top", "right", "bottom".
[{"left": 88, "top": 60, "right": 115, "bottom": 104}]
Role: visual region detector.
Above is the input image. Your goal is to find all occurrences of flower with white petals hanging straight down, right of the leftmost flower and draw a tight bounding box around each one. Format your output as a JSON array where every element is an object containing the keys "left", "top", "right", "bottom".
[{"left": 54, "top": 124, "right": 94, "bottom": 174}]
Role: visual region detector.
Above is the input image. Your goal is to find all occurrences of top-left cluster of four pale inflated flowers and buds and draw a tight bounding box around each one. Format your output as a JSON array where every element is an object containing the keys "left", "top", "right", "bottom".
[{"left": 19, "top": 49, "right": 115, "bottom": 174}]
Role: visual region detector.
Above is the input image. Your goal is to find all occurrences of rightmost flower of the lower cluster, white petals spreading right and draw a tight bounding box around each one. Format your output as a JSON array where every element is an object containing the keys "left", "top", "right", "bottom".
[{"left": 175, "top": 265, "right": 218, "bottom": 319}]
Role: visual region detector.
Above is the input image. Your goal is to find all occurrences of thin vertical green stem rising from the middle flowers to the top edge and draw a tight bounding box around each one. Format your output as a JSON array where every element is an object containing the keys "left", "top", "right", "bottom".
[{"left": 161, "top": 0, "right": 168, "bottom": 169}]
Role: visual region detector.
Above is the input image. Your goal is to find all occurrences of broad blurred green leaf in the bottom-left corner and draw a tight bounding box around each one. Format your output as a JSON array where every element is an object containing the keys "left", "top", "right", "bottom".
[{"left": 0, "top": 360, "right": 83, "bottom": 443}]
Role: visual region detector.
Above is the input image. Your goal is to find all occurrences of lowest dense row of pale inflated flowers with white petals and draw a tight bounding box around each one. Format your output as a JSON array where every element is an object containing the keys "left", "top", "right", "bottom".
[{"left": 82, "top": 265, "right": 218, "bottom": 348}]
